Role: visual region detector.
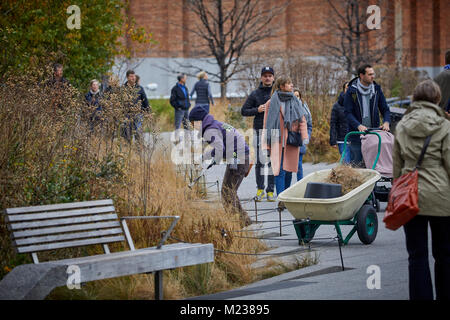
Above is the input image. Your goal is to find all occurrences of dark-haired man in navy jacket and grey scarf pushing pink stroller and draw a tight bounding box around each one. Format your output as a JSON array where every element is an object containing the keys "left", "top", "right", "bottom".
[{"left": 344, "top": 64, "right": 391, "bottom": 167}]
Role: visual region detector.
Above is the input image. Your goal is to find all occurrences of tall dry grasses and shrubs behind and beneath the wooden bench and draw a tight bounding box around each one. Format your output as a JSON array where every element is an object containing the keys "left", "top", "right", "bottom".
[{"left": 0, "top": 61, "right": 265, "bottom": 299}]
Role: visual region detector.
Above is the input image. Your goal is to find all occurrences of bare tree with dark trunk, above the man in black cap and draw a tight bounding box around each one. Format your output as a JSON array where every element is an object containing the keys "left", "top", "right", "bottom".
[{"left": 168, "top": 0, "right": 288, "bottom": 97}]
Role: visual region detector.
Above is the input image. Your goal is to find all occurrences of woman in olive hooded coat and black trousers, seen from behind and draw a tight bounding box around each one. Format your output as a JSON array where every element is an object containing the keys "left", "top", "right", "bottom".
[{"left": 393, "top": 80, "right": 450, "bottom": 300}]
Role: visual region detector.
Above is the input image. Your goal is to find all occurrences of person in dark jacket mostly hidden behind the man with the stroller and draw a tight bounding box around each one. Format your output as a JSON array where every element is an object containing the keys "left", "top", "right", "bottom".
[{"left": 330, "top": 82, "right": 350, "bottom": 164}]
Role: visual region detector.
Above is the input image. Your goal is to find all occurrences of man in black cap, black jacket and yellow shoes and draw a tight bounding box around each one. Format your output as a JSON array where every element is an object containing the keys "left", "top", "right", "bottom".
[{"left": 241, "top": 67, "right": 275, "bottom": 201}]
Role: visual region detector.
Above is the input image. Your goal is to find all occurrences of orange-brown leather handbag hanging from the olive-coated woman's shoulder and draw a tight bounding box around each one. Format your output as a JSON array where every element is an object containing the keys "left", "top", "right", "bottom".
[{"left": 383, "top": 136, "right": 431, "bottom": 230}]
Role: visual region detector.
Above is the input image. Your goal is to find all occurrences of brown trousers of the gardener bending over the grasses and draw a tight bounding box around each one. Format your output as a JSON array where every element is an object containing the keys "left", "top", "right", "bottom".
[{"left": 221, "top": 159, "right": 249, "bottom": 216}]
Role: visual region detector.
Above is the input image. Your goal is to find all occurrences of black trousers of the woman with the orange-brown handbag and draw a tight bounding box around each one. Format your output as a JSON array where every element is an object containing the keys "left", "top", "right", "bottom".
[{"left": 403, "top": 215, "right": 450, "bottom": 300}]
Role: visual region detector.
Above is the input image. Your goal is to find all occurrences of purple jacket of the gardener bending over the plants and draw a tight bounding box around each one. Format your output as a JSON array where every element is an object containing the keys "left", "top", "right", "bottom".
[{"left": 202, "top": 114, "right": 249, "bottom": 163}]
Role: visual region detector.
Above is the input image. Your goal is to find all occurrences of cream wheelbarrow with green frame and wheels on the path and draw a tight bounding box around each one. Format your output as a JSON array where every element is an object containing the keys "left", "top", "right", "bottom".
[{"left": 278, "top": 131, "right": 381, "bottom": 245}]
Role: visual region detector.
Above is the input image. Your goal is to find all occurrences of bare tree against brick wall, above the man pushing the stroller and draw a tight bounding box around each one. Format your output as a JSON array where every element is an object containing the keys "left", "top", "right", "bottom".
[{"left": 322, "top": 0, "right": 399, "bottom": 74}]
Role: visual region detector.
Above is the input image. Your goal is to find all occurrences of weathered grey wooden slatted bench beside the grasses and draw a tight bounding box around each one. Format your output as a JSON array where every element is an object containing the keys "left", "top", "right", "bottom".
[{"left": 0, "top": 199, "right": 214, "bottom": 300}]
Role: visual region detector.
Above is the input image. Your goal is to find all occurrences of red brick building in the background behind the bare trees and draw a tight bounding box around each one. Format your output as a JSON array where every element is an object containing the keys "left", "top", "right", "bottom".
[{"left": 122, "top": 0, "right": 450, "bottom": 96}]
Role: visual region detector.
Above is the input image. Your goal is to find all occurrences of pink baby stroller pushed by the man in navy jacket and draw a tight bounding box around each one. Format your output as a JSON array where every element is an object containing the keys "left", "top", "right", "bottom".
[{"left": 361, "top": 128, "right": 394, "bottom": 212}]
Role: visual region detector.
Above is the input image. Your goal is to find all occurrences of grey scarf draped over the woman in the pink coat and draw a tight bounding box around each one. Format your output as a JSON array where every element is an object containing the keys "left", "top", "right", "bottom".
[{"left": 266, "top": 91, "right": 306, "bottom": 146}]
